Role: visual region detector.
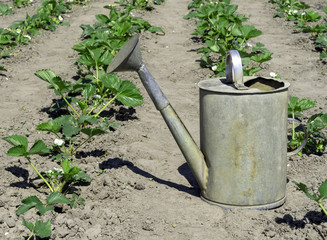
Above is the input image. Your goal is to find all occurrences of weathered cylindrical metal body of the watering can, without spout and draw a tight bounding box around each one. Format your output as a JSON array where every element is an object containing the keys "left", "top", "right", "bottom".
[{"left": 198, "top": 77, "right": 289, "bottom": 209}]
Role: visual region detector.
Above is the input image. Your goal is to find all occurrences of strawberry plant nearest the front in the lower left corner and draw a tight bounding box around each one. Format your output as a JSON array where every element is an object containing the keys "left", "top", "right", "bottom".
[{"left": 3, "top": 135, "right": 90, "bottom": 239}]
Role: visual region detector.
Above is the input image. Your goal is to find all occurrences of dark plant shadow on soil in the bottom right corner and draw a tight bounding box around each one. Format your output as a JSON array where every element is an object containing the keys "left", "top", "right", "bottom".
[{"left": 275, "top": 211, "right": 327, "bottom": 240}]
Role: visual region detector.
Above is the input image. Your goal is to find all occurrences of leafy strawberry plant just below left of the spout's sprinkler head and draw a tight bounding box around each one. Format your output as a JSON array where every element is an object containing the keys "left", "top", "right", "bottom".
[{"left": 36, "top": 68, "right": 142, "bottom": 159}]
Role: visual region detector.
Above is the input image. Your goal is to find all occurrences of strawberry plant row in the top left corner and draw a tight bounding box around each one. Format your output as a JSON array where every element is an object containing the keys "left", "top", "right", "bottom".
[{"left": 0, "top": 0, "right": 92, "bottom": 71}]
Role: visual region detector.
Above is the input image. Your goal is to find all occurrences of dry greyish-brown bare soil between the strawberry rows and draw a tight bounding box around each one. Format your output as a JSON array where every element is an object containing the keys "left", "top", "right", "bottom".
[{"left": 0, "top": 0, "right": 327, "bottom": 240}]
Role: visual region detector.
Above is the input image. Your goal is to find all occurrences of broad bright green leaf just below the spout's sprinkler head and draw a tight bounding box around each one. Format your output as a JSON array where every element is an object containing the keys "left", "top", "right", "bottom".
[{"left": 117, "top": 80, "right": 143, "bottom": 107}]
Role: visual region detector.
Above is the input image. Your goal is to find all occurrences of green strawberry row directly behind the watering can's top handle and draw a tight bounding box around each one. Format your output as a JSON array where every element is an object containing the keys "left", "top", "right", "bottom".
[{"left": 184, "top": 0, "right": 272, "bottom": 77}]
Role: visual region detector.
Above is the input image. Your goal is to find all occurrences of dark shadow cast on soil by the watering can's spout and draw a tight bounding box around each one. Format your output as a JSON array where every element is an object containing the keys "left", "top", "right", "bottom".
[{"left": 99, "top": 158, "right": 200, "bottom": 196}]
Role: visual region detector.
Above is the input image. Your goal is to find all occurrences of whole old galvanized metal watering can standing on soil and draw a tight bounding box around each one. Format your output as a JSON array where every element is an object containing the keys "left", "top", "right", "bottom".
[{"left": 108, "top": 35, "right": 305, "bottom": 209}]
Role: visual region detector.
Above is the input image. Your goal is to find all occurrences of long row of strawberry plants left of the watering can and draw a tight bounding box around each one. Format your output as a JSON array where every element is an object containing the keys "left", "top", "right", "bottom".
[{"left": 3, "top": 2, "right": 163, "bottom": 239}]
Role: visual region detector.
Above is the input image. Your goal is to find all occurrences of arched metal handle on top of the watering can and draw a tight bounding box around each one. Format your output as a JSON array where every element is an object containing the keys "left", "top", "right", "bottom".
[{"left": 225, "top": 50, "right": 248, "bottom": 90}]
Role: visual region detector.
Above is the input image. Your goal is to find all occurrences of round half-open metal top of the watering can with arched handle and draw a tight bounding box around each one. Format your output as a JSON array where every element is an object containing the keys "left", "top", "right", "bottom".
[{"left": 198, "top": 50, "right": 290, "bottom": 94}]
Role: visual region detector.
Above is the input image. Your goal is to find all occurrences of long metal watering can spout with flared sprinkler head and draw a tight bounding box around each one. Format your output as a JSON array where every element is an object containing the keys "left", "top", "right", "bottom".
[{"left": 108, "top": 35, "right": 208, "bottom": 192}]
